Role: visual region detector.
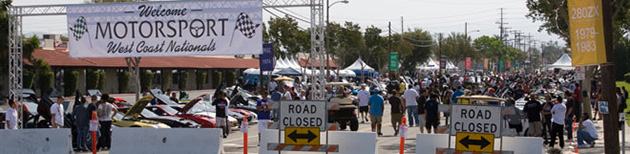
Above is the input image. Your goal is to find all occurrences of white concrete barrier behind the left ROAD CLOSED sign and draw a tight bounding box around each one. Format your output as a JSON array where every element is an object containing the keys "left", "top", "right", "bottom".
[{"left": 258, "top": 129, "right": 378, "bottom": 154}]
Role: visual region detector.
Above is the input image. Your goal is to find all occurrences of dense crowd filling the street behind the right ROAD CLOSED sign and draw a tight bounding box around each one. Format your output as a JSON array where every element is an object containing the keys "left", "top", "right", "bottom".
[{"left": 357, "top": 72, "right": 628, "bottom": 148}]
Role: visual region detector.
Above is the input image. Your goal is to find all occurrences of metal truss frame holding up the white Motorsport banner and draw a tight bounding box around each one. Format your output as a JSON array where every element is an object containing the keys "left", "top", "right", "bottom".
[{"left": 8, "top": 0, "right": 326, "bottom": 102}]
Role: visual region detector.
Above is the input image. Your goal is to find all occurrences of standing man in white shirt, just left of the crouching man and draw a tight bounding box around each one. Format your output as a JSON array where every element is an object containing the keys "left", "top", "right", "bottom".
[{"left": 549, "top": 96, "right": 567, "bottom": 149}]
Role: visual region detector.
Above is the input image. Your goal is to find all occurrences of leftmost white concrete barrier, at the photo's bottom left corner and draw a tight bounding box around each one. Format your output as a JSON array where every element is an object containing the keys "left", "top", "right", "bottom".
[{"left": 0, "top": 129, "right": 72, "bottom": 154}]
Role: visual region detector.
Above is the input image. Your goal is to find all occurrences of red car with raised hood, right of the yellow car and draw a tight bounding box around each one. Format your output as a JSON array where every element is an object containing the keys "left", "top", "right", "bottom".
[{"left": 147, "top": 103, "right": 216, "bottom": 128}]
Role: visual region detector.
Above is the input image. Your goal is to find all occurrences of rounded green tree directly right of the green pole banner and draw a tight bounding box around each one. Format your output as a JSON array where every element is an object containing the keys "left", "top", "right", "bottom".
[{"left": 394, "top": 28, "right": 435, "bottom": 72}]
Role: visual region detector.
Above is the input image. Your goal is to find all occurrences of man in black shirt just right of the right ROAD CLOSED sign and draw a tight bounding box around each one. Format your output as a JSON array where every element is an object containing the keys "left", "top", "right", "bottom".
[{"left": 523, "top": 93, "right": 542, "bottom": 137}]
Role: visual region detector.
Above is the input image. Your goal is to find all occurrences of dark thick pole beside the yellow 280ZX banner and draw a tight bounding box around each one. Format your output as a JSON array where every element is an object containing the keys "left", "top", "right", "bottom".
[{"left": 600, "top": 0, "right": 625, "bottom": 154}]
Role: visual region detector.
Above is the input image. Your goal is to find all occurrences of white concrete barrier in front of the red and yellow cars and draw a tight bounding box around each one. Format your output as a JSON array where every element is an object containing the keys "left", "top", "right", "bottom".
[{"left": 110, "top": 127, "right": 222, "bottom": 154}]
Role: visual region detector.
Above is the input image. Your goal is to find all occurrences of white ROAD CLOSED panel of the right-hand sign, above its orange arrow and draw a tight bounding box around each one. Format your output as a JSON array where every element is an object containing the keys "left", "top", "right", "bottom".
[{"left": 451, "top": 105, "right": 501, "bottom": 137}]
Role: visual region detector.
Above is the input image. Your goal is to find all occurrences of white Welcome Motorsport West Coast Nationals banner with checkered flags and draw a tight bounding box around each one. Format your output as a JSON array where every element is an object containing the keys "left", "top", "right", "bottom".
[{"left": 67, "top": 0, "right": 262, "bottom": 57}]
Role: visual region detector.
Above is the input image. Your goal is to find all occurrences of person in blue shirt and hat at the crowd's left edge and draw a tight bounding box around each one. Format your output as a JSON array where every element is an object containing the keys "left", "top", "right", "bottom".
[{"left": 368, "top": 88, "right": 385, "bottom": 136}]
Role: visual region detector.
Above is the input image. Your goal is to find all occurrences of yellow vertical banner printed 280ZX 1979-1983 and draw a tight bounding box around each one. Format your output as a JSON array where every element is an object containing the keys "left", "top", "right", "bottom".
[{"left": 568, "top": 0, "right": 606, "bottom": 66}]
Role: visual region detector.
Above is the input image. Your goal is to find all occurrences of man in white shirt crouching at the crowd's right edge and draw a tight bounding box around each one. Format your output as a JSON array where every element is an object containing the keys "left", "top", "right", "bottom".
[{"left": 577, "top": 113, "right": 598, "bottom": 148}]
